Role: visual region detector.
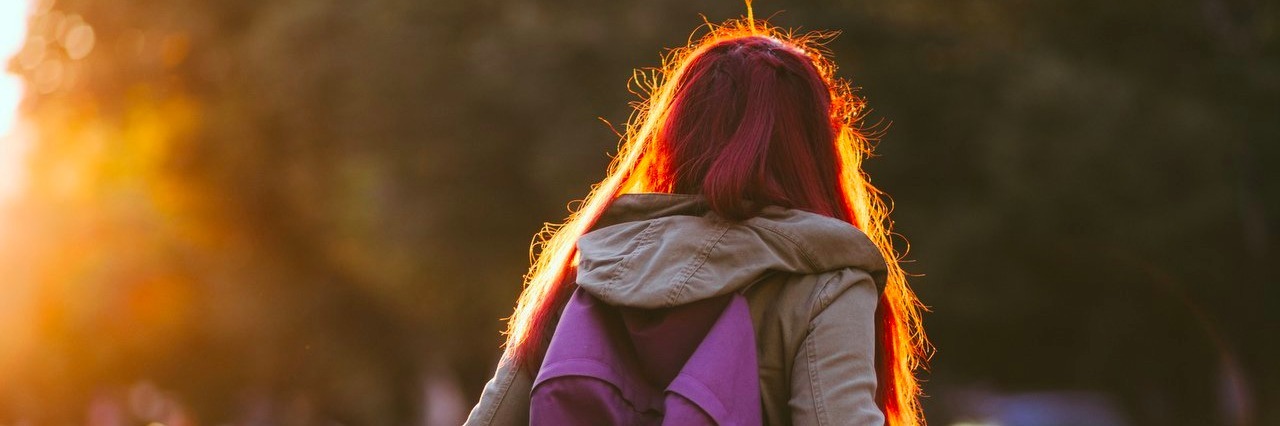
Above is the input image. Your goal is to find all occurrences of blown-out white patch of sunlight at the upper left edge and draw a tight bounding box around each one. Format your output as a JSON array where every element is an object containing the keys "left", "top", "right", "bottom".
[{"left": 0, "top": 0, "right": 31, "bottom": 201}]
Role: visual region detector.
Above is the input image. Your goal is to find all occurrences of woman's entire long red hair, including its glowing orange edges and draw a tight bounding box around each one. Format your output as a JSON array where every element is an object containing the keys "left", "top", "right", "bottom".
[{"left": 507, "top": 17, "right": 927, "bottom": 425}]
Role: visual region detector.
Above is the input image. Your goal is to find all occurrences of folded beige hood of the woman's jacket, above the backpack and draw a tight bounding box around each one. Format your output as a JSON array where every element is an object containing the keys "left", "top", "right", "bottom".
[{"left": 577, "top": 193, "right": 886, "bottom": 308}]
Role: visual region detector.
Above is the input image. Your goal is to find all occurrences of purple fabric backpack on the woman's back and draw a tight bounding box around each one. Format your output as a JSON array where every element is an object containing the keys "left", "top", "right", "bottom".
[{"left": 530, "top": 289, "right": 760, "bottom": 425}]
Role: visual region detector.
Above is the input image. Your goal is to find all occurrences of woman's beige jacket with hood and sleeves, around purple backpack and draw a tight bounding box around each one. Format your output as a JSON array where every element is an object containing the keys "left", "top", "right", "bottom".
[{"left": 466, "top": 193, "right": 884, "bottom": 425}]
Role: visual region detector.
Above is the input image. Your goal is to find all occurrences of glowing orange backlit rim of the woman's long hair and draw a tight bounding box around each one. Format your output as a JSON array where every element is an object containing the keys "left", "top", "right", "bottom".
[{"left": 507, "top": 8, "right": 928, "bottom": 426}]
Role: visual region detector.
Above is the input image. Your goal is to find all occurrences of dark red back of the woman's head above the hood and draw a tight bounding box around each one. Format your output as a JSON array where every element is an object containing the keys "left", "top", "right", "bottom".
[{"left": 646, "top": 35, "right": 850, "bottom": 220}]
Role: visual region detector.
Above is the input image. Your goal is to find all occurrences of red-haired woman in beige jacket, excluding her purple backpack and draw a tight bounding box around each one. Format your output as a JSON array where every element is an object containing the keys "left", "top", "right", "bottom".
[{"left": 467, "top": 15, "right": 927, "bottom": 425}]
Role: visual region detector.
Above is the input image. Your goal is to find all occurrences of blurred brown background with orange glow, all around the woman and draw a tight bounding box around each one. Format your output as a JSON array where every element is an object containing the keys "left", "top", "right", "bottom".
[{"left": 0, "top": 0, "right": 1280, "bottom": 426}]
